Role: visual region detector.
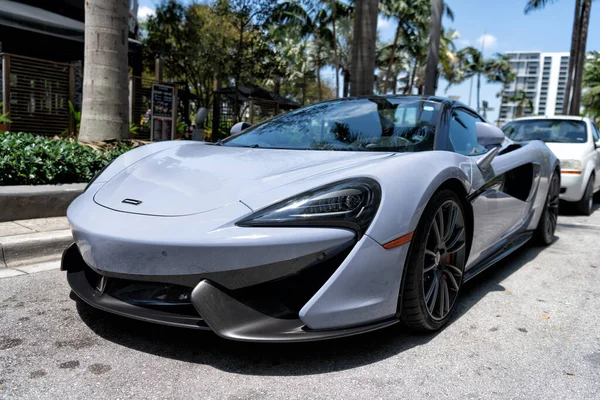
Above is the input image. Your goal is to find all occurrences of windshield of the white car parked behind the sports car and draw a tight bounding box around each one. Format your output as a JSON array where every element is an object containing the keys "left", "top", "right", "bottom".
[{"left": 502, "top": 119, "right": 587, "bottom": 143}]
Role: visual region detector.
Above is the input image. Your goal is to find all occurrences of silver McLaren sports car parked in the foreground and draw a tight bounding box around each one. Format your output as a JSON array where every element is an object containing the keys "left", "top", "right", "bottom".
[{"left": 62, "top": 96, "right": 560, "bottom": 342}]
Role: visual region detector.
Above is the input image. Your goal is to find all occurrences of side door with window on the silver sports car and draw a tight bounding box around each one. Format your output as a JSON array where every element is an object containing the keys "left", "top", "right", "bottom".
[{"left": 449, "top": 107, "right": 534, "bottom": 269}]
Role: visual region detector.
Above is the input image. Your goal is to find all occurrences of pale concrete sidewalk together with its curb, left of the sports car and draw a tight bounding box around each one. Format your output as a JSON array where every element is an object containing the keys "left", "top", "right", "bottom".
[{"left": 0, "top": 217, "right": 73, "bottom": 278}]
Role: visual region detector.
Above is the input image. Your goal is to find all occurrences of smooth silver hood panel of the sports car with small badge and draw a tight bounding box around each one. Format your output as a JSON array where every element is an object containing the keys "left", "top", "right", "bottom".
[{"left": 94, "top": 143, "right": 394, "bottom": 216}]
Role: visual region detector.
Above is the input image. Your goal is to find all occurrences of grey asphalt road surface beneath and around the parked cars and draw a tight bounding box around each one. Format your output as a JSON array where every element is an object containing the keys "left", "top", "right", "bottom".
[{"left": 0, "top": 205, "right": 600, "bottom": 399}]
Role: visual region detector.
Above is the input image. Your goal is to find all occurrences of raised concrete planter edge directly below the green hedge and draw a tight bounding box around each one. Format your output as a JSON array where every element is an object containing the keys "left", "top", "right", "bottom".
[{"left": 0, "top": 183, "right": 86, "bottom": 222}]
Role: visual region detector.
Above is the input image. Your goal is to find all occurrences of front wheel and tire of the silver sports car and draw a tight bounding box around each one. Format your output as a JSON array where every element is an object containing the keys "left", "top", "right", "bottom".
[{"left": 399, "top": 190, "right": 467, "bottom": 332}]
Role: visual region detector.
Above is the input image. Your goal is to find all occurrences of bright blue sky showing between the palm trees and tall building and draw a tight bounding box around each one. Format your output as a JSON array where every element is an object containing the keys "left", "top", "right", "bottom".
[{"left": 138, "top": 0, "right": 600, "bottom": 121}]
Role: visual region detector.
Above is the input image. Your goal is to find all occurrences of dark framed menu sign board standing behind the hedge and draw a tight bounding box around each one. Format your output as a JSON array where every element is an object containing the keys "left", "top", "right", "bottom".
[{"left": 150, "top": 84, "right": 177, "bottom": 141}]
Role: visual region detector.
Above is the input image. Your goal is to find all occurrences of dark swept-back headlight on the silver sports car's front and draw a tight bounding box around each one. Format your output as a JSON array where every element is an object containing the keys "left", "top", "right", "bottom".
[{"left": 237, "top": 178, "right": 381, "bottom": 237}]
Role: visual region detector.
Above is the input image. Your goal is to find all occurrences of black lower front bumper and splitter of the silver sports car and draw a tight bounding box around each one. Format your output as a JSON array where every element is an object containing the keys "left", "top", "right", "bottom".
[{"left": 61, "top": 244, "right": 398, "bottom": 342}]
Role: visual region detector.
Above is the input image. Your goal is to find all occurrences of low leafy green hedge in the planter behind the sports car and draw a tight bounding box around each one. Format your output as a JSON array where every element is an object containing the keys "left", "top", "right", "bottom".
[{"left": 0, "top": 132, "right": 131, "bottom": 186}]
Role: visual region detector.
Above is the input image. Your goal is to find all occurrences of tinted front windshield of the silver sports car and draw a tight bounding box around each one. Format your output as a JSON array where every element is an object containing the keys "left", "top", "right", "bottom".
[{"left": 222, "top": 98, "right": 440, "bottom": 152}]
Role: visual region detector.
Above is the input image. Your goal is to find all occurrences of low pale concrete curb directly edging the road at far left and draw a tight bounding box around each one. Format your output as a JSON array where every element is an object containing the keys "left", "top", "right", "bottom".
[{"left": 0, "top": 229, "right": 73, "bottom": 268}]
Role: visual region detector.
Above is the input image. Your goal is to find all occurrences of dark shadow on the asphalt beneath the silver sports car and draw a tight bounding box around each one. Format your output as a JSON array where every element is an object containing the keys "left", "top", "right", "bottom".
[{"left": 77, "top": 237, "right": 558, "bottom": 376}]
